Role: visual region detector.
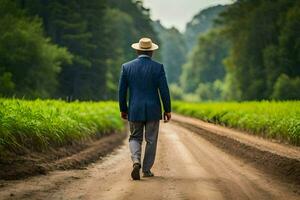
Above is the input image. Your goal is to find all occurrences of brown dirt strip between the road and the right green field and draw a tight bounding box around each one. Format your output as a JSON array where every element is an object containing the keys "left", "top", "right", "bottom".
[{"left": 173, "top": 115, "right": 300, "bottom": 186}]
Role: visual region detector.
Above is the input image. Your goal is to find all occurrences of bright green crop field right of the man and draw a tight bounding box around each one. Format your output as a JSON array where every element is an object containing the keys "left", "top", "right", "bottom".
[{"left": 172, "top": 101, "right": 300, "bottom": 145}]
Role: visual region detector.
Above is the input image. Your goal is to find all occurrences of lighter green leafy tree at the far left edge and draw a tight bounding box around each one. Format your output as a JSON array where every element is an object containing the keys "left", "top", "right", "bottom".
[{"left": 0, "top": 0, "right": 72, "bottom": 98}]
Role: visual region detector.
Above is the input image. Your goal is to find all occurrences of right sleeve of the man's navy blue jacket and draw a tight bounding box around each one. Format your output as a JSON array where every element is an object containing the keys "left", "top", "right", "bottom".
[{"left": 158, "top": 65, "right": 171, "bottom": 112}]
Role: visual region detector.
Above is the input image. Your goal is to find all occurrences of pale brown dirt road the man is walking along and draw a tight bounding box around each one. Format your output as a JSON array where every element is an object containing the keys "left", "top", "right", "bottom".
[{"left": 0, "top": 124, "right": 300, "bottom": 200}]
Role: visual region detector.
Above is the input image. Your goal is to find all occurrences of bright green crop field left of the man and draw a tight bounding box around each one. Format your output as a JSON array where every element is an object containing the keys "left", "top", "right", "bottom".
[{"left": 0, "top": 99, "right": 123, "bottom": 151}]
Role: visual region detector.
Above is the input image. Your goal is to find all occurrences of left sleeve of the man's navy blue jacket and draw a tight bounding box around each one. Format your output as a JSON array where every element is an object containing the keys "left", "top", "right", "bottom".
[{"left": 119, "top": 65, "right": 128, "bottom": 113}]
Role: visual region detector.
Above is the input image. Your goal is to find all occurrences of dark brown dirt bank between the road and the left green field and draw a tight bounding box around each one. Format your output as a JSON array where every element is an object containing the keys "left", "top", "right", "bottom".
[{"left": 0, "top": 133, "right": 126, "bottom": 180}]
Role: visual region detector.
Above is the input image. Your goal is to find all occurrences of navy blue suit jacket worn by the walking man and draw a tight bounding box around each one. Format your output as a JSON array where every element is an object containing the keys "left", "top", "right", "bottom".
[{"left": 119, "top": 55, "right": 171, "bottom": 121}]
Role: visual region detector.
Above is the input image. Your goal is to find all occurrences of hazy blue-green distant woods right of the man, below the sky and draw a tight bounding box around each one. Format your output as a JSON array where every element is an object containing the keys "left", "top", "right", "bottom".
[{"left": 154, "top": 5, "right": 229, "bottom": 101}]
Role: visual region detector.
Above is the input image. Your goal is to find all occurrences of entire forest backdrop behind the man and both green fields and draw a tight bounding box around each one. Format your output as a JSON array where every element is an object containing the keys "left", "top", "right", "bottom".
[{"left": 0, "top": 0, "right": 300, "bottom": 101}]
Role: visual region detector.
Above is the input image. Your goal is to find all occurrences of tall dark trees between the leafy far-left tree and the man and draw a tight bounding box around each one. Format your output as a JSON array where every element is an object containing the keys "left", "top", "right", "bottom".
[{"left": 15, "top": 0, "right": 159, "bottom": 100}]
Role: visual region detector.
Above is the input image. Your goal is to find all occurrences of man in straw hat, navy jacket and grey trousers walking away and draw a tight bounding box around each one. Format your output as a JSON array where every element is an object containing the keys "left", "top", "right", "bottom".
[{"left": 119, "top": 38, "right": 171, "bottom": 180}]
